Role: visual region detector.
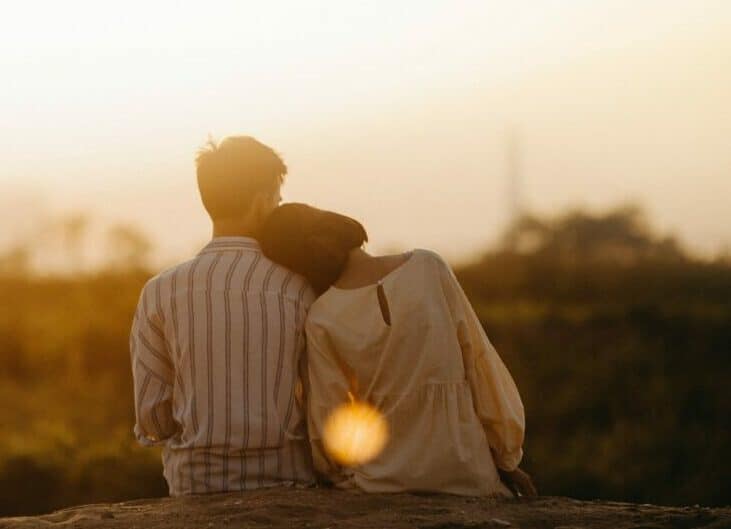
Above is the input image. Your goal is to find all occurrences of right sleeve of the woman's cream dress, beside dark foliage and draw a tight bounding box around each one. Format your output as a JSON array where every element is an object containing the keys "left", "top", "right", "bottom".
[{"left": 434, "top": 262, "right": 525, "bottom": 471}]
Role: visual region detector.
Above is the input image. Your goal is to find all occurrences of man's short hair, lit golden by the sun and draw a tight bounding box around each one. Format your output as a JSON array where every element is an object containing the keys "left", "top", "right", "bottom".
[{"left": 195, "top": 136, "right": 287, "bottom": 220}]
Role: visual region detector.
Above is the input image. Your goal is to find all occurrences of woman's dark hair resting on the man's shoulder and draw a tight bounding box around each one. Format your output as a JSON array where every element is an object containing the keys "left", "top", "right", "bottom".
[{"left": 259, "top": 203, "right": 368, "bottom": 295}]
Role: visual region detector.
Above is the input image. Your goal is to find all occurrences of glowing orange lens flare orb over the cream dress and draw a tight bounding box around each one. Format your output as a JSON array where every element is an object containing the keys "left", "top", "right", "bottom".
[{"left": 323, "top": 401, "right": 388, "bottom": 467}]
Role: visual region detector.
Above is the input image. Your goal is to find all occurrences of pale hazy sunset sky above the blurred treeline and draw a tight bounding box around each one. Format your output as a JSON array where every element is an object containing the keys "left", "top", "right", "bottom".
[{"left": 0, "top": 0, "right": 731, "bottom": 259}]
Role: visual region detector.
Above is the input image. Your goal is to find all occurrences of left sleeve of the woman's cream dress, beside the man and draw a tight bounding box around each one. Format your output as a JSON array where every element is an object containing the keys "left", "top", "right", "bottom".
[{"left": 306, "top": 322, "right": 349, "bottom": 485}]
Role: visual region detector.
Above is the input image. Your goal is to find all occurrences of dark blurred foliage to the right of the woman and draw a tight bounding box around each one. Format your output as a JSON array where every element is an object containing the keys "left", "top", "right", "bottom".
[{"left": 457, "top": 207, "right": 731, "bottom": 505}]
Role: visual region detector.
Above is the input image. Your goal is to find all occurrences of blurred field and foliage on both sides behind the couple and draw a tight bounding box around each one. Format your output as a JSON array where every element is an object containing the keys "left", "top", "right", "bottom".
[{"left": 0, "top": 207, "right": 731, "bottom": 515}]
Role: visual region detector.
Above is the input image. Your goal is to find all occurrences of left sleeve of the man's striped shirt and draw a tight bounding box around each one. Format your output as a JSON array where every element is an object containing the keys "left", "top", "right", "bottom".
[{"left": 130, "top": 280, "right": 178, "bottom": 446}]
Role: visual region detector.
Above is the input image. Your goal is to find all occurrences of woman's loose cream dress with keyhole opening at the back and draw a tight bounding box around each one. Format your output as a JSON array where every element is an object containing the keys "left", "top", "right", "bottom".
[{"left": 305, "top": 250, "right": 525, "bottom": 496}]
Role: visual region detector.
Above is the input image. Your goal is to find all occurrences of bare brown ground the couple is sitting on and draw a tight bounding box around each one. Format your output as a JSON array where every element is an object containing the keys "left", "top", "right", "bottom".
[{"left": 0, "top": 488, "right": 731, "bottom": 529}]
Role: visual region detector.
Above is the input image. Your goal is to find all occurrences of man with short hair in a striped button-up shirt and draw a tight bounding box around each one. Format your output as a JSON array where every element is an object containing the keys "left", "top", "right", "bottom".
[{"left": 130, "top": 136, "right": 315, "bottom": 496}]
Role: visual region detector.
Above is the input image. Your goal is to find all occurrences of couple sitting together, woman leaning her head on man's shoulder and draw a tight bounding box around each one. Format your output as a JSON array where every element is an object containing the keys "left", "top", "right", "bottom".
[{"left": 130, "top": 136, "right": 535, "bottom": 496}]
